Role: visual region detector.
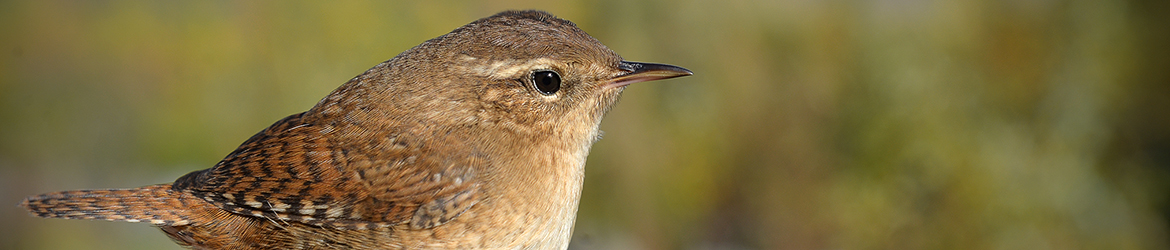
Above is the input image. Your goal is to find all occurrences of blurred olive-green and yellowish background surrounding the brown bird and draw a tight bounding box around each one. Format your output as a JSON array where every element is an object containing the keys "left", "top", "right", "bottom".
[{"left": 0, "top": 0, "right": 1170, "bottom": 249}]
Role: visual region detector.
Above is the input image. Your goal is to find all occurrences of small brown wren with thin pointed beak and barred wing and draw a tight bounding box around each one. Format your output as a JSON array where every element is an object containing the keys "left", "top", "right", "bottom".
[{"left": 20, "top": 11, "right": 693, "bottom": 250}]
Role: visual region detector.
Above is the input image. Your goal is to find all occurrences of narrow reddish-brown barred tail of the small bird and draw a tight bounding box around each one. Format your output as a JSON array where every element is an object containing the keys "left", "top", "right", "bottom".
[{"left": 20, "top": 185, "right": 201, "bottom": 225}]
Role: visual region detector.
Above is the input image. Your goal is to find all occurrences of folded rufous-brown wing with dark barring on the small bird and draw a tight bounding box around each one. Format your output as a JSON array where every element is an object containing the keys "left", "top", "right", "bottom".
[{"left": 173, "top": 113, "right": 480, "bottom": 229}]
